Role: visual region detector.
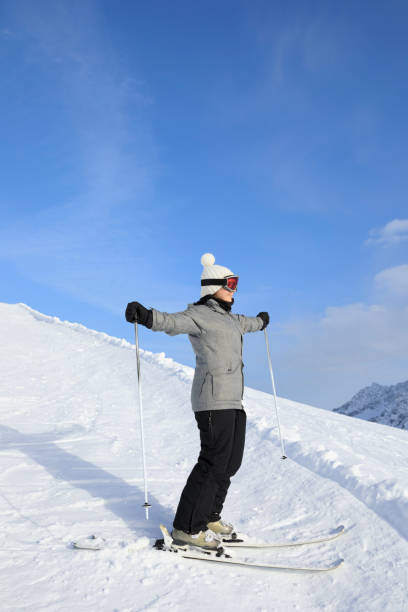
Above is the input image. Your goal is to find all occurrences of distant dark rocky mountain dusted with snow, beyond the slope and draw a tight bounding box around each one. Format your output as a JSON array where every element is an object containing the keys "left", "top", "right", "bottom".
[{"left": 334, "top": 381, "right": 408, "bottom": 430}]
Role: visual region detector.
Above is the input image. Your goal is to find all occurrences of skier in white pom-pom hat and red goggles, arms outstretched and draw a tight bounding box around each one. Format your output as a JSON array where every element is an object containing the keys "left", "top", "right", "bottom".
[{"left": 125, "top": 253, "right": 269, "bottom": 550}]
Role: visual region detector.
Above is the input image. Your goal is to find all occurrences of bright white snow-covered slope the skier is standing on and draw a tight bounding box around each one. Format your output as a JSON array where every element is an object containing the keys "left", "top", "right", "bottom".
[{"left": 0, "top": 304, "right": 408, "bottom": 612}]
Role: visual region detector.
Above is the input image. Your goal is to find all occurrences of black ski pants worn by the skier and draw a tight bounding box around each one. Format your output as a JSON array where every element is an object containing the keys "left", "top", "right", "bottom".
[{"left": 173, "top": 409, "right": 246, "bottom": 533}]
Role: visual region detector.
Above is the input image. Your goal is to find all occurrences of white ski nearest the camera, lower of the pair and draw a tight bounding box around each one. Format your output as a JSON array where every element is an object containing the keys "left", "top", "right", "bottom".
[{"left": 154, "top": 525, "right": 344, "bottom": 573}]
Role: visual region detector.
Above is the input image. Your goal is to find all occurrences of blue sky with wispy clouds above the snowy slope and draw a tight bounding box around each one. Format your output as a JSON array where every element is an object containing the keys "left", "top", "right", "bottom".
[{"left": 0, "top": 0, "right": 408, "bottom": 408}]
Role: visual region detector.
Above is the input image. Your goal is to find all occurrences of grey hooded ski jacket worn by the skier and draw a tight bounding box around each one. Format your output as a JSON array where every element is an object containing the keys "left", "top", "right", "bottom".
[{"left": 152, "top": 299, "right": 263, "bottom": 412}]
